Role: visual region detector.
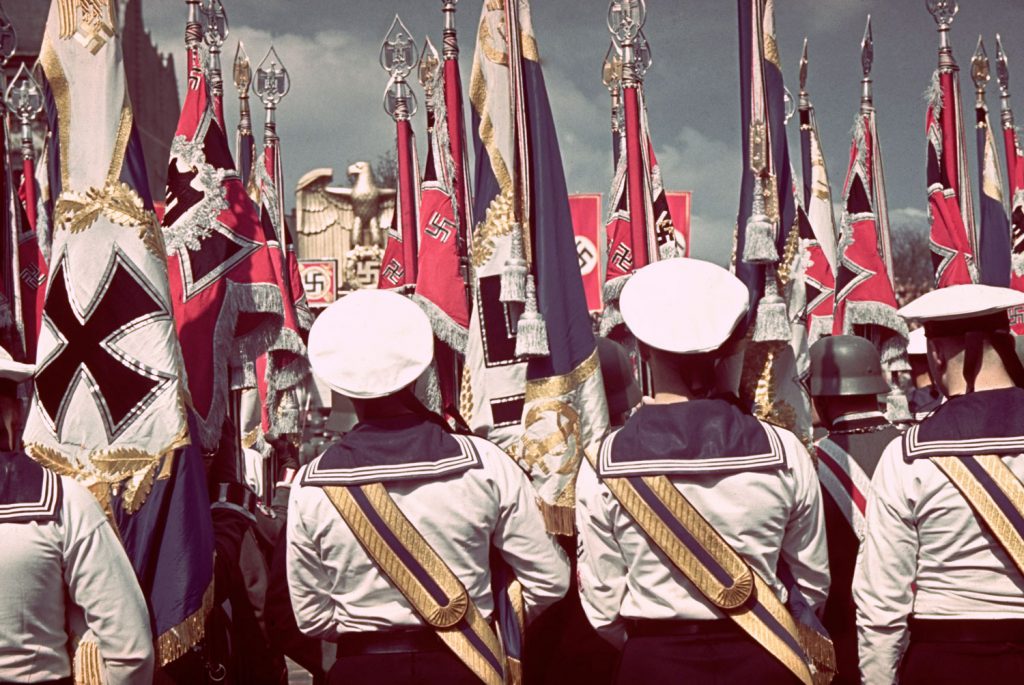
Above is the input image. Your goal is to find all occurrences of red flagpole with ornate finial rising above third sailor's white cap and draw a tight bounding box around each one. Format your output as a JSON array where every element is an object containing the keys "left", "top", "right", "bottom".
[{"left": 608, "top": 0, "right": 650, "bottom": 268}]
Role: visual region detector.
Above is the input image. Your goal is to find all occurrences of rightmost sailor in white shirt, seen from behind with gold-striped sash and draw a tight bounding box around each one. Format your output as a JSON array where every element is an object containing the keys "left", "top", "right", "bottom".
[{"left": 853, "top": 285, "right": 1024, "bottom": 685}]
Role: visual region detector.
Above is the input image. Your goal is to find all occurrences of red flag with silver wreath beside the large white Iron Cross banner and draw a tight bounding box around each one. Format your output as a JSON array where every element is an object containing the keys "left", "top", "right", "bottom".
[{"left": 163, "top": 24, "right": 283, "bottom": 449}]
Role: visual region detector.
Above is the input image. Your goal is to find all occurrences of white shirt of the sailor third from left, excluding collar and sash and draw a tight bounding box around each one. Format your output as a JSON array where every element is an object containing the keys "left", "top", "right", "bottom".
[{"left": 577, "top": 429, "right": 828, "bottom": 644}]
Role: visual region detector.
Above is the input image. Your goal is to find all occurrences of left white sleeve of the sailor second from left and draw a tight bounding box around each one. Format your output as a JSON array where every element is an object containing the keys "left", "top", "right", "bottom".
[{"left": 286, "top": 485, "right": 337, "bottom": 639}]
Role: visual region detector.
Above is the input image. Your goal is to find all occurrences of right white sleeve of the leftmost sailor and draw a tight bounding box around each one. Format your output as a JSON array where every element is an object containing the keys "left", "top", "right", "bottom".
[{"left": 62, "top": 479, "right": 154, "bottom": 685}]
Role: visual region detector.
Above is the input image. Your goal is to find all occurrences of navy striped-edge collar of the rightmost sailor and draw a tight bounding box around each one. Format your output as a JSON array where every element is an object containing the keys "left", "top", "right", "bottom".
[{"left": 903, "top": 387, "right": 1024, "bottom": 461}]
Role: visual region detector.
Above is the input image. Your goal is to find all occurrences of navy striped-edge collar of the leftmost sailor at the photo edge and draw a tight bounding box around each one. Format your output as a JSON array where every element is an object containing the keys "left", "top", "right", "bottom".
[{"left": 0, "top": 452, "right": 63, "bottom": 523}]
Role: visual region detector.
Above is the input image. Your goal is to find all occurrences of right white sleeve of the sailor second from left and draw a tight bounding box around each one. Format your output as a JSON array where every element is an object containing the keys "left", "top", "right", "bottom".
[{"left": 481, "top": 445, "right": 569, "bottom": 620}]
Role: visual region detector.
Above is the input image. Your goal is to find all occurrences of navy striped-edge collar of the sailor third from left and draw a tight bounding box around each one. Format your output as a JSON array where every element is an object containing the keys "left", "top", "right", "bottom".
[{"left": 597, "top": 398, "right": 785, "bottom": 478}]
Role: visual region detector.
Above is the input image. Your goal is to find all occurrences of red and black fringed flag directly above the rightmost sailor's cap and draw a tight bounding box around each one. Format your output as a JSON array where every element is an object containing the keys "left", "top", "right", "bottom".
[{"left": 925, "top": 34, "right": 978, "bottom": 288}]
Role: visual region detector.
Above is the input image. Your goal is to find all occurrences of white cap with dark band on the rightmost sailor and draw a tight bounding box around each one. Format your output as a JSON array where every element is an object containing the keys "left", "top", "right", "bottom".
[{"left": 899, "top": 284, "right": 1024, "bottom": 335}]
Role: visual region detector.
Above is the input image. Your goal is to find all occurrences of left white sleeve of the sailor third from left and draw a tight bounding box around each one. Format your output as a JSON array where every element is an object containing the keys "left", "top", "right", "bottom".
[{"left": 577, "top": 462, "right": 628, "bottom": 647}]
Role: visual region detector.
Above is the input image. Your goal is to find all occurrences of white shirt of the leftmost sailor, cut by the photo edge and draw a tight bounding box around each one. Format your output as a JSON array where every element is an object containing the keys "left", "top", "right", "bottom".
[{"left": 0, "top": 477, "right": 154, "bottom": 685}]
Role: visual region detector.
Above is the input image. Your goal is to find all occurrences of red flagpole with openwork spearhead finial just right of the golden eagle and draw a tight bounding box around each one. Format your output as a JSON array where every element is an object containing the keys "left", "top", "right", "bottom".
[{"left": 380, "top": 14, "right": 419, "bottom": 285}]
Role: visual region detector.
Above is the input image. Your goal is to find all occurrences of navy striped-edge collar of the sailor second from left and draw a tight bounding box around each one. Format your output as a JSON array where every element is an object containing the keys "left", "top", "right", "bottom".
[{"left": 302, "top": 416, "right": 482, "bottom": 486}]
